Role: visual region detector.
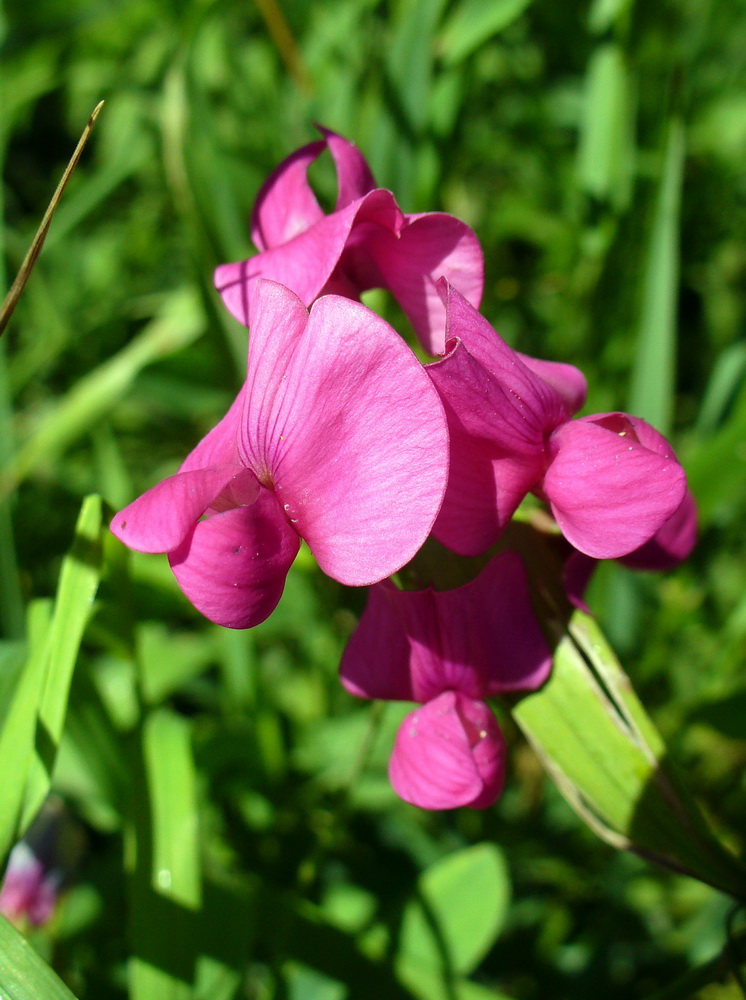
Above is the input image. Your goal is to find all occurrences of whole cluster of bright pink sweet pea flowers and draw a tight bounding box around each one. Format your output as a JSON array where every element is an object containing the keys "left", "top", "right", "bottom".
[{"left": 112, "top": 129, "right": 696, "bottom": 809}]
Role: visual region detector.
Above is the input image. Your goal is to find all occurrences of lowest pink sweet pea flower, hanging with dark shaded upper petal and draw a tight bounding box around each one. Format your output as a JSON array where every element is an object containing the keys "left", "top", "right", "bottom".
[{"left": 340, "top": 551, "right": 551, "bottom": 809}]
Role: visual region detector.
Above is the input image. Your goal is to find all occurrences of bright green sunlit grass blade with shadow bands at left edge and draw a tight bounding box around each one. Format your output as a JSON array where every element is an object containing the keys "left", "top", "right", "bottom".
[{"left": 21, "top": 496, "right": 103, "bottom": 829}]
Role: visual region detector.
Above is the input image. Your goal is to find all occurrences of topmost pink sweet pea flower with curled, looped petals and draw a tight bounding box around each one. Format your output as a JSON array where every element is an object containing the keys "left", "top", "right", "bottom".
[{"left": 215, "top": 129, "right": 484, "bottom": 355}]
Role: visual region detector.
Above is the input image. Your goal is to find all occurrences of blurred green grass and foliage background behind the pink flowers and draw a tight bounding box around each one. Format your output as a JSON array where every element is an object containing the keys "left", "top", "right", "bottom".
[{"left": 0, "top": 0, "right": 746, "bottom": 1000}]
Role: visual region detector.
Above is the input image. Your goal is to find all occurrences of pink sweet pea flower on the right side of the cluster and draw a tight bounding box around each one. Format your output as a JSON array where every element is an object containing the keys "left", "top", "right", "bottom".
[{"left": 427, "top": 283, "right": 686, "bottom": 559}]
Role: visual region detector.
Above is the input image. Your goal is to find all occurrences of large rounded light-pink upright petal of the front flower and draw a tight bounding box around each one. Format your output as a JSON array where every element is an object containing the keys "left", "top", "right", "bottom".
[{"left": 243, "top": 286, "right": 448, "bottom": 586}]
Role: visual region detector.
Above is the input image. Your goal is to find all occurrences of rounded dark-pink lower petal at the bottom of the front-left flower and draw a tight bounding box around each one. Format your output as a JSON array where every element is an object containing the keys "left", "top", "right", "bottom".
[{"left": 169, "top": 490, "right": 300, "bottom": 628}]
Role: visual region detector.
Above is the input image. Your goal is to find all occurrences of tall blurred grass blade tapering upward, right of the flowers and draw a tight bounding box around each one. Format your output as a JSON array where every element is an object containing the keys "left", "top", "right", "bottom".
[{"left": 629, "top": 118, "right": 685, "bottom": 434}]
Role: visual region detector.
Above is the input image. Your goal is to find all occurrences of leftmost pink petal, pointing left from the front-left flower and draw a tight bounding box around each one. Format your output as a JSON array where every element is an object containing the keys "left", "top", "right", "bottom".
[{"left": 111, "top": 465, "right": 259, "bottom": 552}]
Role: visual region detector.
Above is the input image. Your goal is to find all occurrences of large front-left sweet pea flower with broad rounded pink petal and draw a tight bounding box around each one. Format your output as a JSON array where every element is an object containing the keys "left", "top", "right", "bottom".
[{"left": 111, "top": 280, "right": 448, "bottom": 628}]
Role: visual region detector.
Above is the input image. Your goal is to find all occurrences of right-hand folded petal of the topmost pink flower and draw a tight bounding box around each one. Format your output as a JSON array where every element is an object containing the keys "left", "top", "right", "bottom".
[{"left": 366, "top": 212, "right": 484, "bottom": 355}]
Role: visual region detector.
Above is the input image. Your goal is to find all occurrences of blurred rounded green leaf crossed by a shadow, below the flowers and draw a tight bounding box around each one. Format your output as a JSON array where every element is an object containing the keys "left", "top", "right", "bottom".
[{"left": 399, "top": 844, "right": 510, "bottom": 973}]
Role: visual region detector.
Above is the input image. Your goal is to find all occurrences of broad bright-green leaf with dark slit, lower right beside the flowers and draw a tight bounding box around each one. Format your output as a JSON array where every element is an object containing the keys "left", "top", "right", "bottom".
[{"left": 513, "top": 611, "right": 746, "bottom": 899}]
